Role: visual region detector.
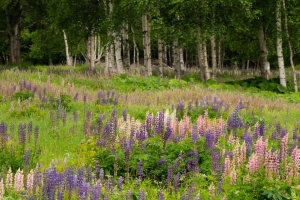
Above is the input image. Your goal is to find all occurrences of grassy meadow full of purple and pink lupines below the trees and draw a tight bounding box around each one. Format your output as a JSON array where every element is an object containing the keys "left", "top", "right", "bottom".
[{"left": 0, "top": 66, "right": 300, "bottom": 199}]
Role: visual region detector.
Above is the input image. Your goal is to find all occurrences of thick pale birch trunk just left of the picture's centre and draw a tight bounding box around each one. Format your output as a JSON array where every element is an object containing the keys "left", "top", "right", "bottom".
[{"left": 142, "top": 14, "right": 152, "bottom": 76}]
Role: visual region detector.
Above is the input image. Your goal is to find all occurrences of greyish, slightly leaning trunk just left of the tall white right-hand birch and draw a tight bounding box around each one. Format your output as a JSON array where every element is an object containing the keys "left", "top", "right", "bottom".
[{"left": 258, "top": 25, "right": 270, "bottom": 79}]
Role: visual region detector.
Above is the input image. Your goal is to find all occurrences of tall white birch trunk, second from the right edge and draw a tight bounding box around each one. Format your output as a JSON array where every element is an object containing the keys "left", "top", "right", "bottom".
[{"left": 276, "top": 0, "right": 286, "bottom": 87}]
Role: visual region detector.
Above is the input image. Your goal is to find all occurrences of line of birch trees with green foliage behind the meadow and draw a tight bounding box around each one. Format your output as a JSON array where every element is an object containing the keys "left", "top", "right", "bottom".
[{"left": 0, "top": 0, "right": 300, "bottom": 89}]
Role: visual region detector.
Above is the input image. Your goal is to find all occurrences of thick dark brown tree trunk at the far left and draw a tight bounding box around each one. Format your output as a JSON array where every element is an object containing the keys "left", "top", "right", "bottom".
[{"left": 7, "top": 0, "right": 22, "bottom": 63}]
